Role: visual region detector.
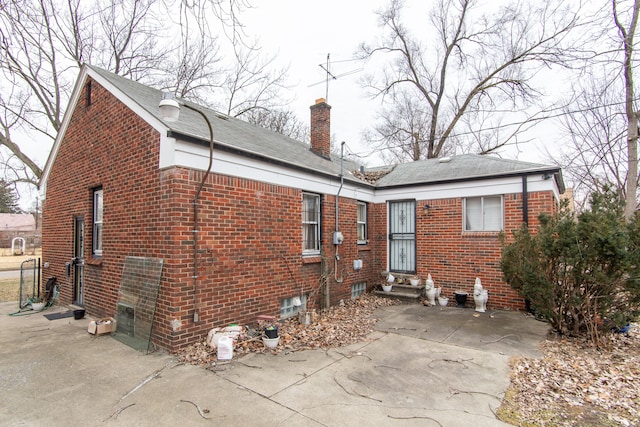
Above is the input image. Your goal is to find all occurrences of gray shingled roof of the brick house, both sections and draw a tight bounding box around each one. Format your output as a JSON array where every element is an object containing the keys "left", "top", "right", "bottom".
[{"left": 89, "top": 66, "right": 564, "bottom": 188}]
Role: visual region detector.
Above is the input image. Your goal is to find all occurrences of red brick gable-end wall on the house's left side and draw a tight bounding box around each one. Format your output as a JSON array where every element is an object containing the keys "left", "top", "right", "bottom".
[{"left": 42, "top": 77, "right": 172, "bottom": 324}]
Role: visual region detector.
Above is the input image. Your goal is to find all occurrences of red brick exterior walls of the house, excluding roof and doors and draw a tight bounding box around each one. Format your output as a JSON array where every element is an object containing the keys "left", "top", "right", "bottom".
[{"left": 42, "top": 77, "right": 553, "bottom": 350}]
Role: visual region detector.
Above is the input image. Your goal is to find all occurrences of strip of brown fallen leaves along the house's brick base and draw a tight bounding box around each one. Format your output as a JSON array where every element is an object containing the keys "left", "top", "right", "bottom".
[{"left": 178, "top": 294, "right": 398, "bottom": 365}]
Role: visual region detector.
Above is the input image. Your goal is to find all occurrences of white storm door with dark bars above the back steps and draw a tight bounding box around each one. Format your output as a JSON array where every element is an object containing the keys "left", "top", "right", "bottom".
[{"left": 389, "top": 200, "right": 416, "bottom": 273}]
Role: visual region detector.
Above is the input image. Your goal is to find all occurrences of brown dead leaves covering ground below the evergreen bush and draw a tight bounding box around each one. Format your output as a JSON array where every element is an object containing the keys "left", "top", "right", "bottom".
[{"left": 499, "top": 324, "right": 640, "bottom": 426}]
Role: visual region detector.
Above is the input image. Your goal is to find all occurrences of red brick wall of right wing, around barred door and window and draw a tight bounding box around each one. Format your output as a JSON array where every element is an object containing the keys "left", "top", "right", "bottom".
[{"left": 375, "top": 192, "right": 556, "bottom": 309}]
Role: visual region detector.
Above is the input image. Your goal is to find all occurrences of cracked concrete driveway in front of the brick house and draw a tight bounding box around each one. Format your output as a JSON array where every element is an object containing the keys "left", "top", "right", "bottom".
[{"left": 0, "top": 303, "right": 547, "bottom": 427}]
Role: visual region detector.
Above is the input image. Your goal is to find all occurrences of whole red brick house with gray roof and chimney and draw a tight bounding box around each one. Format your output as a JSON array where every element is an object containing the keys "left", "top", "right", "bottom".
[{"left": 41, "top": 66, "right": 563, "bottom": 350}]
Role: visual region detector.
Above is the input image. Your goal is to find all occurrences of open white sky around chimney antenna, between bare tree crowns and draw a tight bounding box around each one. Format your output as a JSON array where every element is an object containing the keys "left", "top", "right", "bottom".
[{"left": 242, "top": 0, "right": 387, "bottom": 166}]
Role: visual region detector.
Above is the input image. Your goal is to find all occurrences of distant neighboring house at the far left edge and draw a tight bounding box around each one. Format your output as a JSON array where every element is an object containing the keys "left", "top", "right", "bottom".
[{"left": 0, "top": 213, "right": 40, "bottom": 255}]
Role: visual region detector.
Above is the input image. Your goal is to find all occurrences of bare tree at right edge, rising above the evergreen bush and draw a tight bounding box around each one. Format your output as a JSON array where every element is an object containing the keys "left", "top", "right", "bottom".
[{"left": 549, "top": 0, "right": 640, "bottom": 214}]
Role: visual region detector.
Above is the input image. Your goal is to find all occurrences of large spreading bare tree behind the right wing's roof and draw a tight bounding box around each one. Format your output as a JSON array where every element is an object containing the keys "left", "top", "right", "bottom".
[{"left": 359, "top": 0, "right": 578, "bottom": 158}]
